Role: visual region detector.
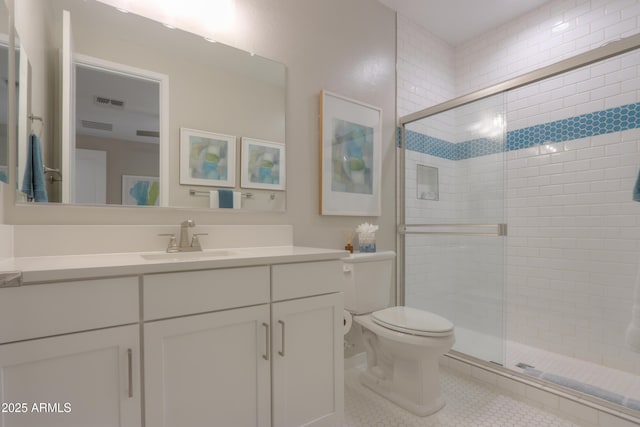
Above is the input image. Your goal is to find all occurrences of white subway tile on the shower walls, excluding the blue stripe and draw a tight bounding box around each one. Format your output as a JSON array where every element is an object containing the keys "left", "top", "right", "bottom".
[{"left": 398, "top": 0, "right": 640, "bottom": 404}]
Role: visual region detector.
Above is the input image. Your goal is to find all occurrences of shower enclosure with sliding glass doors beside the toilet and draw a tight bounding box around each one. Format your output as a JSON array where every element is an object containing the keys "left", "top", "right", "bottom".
[{"left": 398, "top": 36, "right": 640, "bottom": 416}]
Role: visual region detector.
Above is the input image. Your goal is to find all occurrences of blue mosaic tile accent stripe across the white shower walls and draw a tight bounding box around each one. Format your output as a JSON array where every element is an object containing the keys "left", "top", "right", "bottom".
[{"left": 404, "top": 102, "right": 640, "bottom": 160}]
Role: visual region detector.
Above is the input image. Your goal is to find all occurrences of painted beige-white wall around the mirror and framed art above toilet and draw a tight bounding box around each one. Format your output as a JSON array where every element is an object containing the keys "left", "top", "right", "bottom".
[{"left": 5, "top": 0, "right": 396, "bottom": 254}]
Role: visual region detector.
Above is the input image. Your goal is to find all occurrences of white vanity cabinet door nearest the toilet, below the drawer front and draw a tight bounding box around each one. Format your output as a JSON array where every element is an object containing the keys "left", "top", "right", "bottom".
[{"left": 272, "top": 293, "right": 344, "bottom": 427}]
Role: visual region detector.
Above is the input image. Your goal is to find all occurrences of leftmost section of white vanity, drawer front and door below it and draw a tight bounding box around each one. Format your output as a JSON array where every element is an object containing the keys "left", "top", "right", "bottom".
[{"left": 0, "top": 277, "right": 141, "bottom": 427}]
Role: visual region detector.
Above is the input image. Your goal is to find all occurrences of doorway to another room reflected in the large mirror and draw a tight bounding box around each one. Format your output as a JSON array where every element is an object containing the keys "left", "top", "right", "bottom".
[{"left": 73, "top": 58, "right": 162, "bottom": 206}]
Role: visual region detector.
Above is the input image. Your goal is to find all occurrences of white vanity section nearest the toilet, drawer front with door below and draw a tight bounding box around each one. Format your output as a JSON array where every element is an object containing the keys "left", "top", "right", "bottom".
[{"left": 271, "top": 261, "right": 344, "bottom": 427}]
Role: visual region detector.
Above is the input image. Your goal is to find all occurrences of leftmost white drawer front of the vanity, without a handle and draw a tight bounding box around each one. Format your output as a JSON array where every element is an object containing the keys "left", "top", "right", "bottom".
[{"left": 0, "top": 277, "right": 140, "bottom": 343}]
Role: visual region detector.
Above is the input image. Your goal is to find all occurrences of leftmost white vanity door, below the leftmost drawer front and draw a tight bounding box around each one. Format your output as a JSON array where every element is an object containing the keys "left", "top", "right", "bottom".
[{"left": 0, "top": 325, "right": 141, "bottom": 427}]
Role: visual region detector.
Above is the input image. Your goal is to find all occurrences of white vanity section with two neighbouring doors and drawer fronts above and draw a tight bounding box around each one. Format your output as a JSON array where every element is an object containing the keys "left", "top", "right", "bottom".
[{"left": 143, "top": 261, "right": 344, "bottom": 427}]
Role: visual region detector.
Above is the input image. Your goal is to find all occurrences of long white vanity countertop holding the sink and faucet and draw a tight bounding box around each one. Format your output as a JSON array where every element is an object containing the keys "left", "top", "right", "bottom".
[{"left": 0, "top": 246, "right": 349, "bottom": 285}]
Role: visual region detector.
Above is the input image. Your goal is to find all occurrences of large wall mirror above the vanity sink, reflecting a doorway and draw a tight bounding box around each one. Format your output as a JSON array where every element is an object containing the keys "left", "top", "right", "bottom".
[{"left": 15, "top": 0, "right": 286, "bottom": 211}]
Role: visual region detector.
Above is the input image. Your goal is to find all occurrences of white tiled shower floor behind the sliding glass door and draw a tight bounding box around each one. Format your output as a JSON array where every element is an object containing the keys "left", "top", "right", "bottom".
[{"left": 454, "top": 327, "right": 640, "bottom": 408}]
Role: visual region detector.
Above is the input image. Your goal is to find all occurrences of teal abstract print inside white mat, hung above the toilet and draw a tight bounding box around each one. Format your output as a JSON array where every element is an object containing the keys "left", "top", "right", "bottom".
[{"left": 331, "top": 118, "right": 374, "bottom": 194}]
